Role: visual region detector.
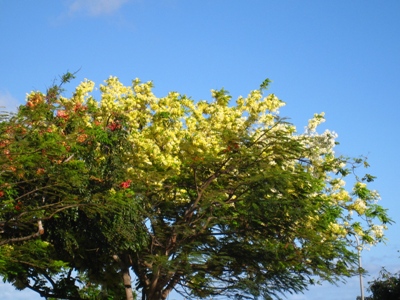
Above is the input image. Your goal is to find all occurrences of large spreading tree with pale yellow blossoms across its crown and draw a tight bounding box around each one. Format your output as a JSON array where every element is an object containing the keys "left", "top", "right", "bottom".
[{"left": 1, "top": 77, "right": 391, "bottom": 300}]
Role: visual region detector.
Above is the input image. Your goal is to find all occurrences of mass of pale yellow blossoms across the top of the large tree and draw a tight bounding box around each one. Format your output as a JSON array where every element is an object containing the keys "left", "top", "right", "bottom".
[{"left": 50, "top": 77, "right": 388, "bottom": 244}]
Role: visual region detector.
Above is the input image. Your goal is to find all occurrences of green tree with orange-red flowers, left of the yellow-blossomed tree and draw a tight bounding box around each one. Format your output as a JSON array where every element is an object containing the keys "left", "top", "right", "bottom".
[{"left": 0, "top": 74, "right": 141, "bottom": 299}]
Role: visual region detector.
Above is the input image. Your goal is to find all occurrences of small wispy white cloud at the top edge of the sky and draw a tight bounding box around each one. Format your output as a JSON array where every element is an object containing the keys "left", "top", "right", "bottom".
[{"left": 69, "top": 0, "right": 130, "bottom": 16}]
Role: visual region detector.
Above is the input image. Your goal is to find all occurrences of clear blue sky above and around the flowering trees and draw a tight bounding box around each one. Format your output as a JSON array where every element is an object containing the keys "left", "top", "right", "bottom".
[{"left": 0, "top": 0, "right": 400, "bottom": 300}]
